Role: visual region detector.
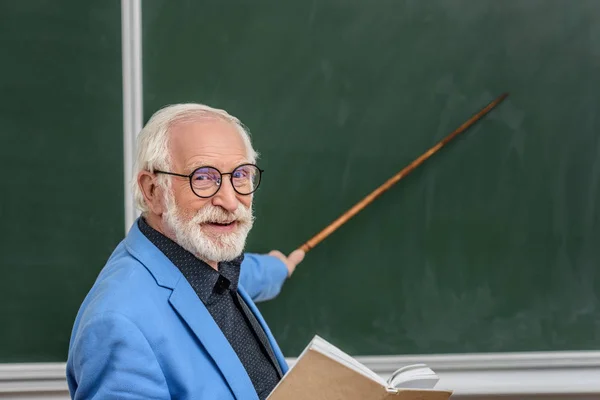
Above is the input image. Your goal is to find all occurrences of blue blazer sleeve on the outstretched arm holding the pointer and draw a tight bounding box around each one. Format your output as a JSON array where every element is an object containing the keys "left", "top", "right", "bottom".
[{"left": 240, "top": 253, "right": 288, "bottom": 302}]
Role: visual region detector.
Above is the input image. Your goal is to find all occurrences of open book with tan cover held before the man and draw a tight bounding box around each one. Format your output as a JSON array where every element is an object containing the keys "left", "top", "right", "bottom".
[{"left": 268, "top": 336, "right": 452, "bottom": 400}]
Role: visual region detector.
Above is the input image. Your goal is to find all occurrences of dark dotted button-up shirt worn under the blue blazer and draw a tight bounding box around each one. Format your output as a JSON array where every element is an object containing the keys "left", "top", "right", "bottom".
[{"left": 138, "top": 218, "right": 282, "bottom": 400}]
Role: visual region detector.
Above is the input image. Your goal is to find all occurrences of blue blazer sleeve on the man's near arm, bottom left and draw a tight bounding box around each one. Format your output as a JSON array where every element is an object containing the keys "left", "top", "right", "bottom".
[{"left": 67, "top": 313, "right": 171, "bottom": 400}]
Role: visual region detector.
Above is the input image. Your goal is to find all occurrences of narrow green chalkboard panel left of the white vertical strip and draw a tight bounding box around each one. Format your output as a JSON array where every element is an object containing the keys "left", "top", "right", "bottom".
[{"left": 0, "top": 0, "right": 124, "bottom": 362}]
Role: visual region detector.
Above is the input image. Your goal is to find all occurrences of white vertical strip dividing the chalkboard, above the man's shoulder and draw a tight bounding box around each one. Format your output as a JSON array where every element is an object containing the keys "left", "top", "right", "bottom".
[{"left": 121, "top": 0, "right": 143, "bottom": 233}]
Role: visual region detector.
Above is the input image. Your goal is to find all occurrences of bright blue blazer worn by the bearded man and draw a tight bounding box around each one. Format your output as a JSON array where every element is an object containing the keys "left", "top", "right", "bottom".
[{"left": 67, "top": 221, "right": 288, "bottom": 400}]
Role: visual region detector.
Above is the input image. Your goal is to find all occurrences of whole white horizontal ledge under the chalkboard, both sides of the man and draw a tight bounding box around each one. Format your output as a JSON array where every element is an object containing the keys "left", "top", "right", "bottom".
[{"left": 0, "top": 351, "right": 600, "bottom": 398}]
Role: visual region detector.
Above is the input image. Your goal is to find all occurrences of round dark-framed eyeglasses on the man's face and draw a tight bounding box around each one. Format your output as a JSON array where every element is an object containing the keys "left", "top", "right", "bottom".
[{"left": 154, "top": 164, "right": 264, "bottom": 198}]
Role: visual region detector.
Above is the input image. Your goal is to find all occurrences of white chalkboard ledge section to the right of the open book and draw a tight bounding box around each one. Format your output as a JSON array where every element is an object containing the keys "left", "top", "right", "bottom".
[{"left": 358, "top": 351, "right": 600, "bottom": 398}]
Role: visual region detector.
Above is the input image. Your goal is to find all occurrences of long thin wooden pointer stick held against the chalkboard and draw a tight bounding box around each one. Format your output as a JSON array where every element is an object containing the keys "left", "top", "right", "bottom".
[{"left": 300, "top": 93, "right": 508, "bottom": 253}]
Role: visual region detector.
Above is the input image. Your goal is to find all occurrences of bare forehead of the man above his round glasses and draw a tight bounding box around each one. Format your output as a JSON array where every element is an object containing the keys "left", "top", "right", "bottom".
[{"left": 169, "top": 117, "right": 247, "bottom": 169}]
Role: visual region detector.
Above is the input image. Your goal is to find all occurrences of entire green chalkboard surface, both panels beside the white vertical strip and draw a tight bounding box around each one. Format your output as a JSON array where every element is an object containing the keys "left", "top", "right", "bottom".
[{"left": 0, "top": 0, "right": 600, "bottom": 362}]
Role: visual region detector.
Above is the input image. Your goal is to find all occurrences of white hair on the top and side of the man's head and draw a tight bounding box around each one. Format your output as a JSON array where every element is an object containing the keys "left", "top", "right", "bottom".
[{"left": 131, "top": 103, "right": 258, "bottom": 213}]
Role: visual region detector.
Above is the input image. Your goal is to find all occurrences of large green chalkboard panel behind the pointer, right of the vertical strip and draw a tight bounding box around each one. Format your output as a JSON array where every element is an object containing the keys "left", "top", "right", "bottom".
[{"left": 143, "top": 0, "right": 600, "bottom": 356}]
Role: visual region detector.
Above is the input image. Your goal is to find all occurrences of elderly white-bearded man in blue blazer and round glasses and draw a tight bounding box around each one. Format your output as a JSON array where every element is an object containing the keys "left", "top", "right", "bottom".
[{"left": 67, "top": 104, "right": 304, "bottom": 400}]
